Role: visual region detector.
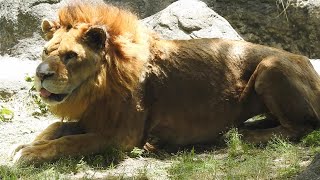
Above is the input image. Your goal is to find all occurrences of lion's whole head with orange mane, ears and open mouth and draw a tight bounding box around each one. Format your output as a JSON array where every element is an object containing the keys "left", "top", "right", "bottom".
[{"left": 35, "top": 3, "right": 150, "bottom": 119}]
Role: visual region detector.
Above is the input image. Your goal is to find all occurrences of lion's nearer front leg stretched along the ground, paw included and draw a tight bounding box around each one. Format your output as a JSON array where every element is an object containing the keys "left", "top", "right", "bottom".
[{"left": 13, "top": 133, "right": 107, "bottom": 164}]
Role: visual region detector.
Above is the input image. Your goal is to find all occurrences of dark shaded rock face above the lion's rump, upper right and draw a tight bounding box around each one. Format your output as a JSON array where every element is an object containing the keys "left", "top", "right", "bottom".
[{"left": 212, "top": 0, "right": 320, "bottom": 58}]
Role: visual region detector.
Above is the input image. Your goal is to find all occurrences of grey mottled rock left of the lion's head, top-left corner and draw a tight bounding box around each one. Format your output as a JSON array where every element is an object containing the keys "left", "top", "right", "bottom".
[{"left": 0, "top": 0, "right": 59, "bottom": 60}]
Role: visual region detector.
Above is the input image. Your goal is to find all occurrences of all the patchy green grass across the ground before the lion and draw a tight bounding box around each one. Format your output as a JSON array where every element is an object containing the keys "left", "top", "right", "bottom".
[{"left": 0, "top": 129, "right": 320, "bottom": 180}]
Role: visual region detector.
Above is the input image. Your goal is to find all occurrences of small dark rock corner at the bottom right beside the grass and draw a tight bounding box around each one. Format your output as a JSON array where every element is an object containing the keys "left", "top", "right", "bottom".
[{"left": 296, "top": 154, "right": 320, "bottom": 180}]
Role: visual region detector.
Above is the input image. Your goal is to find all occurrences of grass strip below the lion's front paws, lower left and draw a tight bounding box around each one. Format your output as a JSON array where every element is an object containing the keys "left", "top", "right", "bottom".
[{"left": 0, "top": 148, "right": 125, "bottom": 180}]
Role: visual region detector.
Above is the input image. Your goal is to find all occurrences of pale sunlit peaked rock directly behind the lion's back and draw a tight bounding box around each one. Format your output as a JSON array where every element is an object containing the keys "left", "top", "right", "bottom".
[{"left": 142, "top": 0, "right": 242, "bottom": 40}]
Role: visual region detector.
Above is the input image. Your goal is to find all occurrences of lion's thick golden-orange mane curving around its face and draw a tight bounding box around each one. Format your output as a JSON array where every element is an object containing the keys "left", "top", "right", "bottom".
[{"left": 51, "top": 2, "right": 151, "bottom": 119}]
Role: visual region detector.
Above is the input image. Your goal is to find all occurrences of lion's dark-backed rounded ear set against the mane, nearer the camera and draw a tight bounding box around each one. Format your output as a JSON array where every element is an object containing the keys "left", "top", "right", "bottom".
[{"left": 83, "top": 26, "right": 109, "bottom": 49}]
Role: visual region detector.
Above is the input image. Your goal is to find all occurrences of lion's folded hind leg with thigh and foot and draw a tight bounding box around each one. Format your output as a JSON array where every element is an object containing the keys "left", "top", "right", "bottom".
[{"left": 243, "top": 56, "right": 320, "bottom": 143}]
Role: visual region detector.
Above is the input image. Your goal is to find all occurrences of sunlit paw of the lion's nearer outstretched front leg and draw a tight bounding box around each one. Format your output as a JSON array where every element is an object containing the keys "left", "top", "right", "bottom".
[{"left": 13, "top": 141, "right": 55, "bottom": 165}]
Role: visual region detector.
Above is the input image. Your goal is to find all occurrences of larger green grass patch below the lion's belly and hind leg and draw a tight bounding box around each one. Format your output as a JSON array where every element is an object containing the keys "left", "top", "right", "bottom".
[{"left": 169, "top": 129, "right": 306, "bottom": 179}]
